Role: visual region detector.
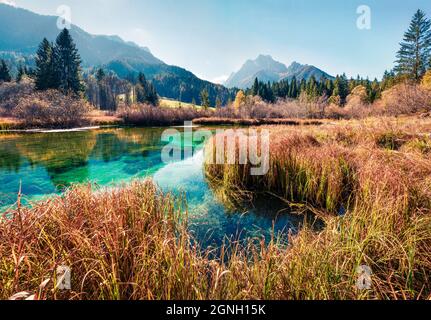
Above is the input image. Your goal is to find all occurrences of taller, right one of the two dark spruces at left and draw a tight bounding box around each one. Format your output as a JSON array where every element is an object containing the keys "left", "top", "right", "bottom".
[{"left": 54, "top": 28, "right": 84, "bottom": 95}]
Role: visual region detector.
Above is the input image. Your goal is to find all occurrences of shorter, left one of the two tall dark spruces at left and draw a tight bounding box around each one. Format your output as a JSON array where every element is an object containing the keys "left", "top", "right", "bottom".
[{"left": 35, "top": 38, "right": 58, "bottom": 90}]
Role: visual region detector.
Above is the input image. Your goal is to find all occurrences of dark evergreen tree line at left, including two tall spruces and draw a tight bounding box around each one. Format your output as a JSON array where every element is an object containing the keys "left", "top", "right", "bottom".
[{"left": 0, "top": 29, "right": 159, "bottom": 110}]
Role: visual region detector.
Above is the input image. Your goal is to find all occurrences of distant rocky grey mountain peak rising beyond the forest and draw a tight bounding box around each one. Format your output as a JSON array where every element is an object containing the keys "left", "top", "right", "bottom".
[{"left": 225, "top": 55, "right": 333, "bottom": 89}]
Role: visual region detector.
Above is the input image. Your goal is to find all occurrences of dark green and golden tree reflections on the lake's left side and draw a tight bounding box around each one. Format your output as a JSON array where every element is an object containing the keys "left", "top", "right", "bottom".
[{"left": 0, "top": 128, "right": 167, "bottom": 189}]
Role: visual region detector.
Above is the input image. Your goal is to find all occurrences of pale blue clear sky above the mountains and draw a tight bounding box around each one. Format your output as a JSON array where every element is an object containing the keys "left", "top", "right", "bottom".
[{"left": 0, "top": 0, "right": 431, "bottom": 82}]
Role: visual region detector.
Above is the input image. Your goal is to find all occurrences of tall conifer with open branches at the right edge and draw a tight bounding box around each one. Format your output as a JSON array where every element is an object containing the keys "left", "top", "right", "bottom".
[{"left": 395, "top": 10, "right": 431, "bottom": 80}]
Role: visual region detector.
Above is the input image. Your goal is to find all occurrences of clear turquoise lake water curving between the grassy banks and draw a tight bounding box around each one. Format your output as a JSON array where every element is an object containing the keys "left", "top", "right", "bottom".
[{"left": 0, "top": 128, "right": 302, "bottom": 247}]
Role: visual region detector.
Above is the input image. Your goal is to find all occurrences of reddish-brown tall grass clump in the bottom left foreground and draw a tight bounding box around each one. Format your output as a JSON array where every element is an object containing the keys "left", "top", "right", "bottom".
[{"left": 0, "top": 181, "right": 213, "bottom": 300}]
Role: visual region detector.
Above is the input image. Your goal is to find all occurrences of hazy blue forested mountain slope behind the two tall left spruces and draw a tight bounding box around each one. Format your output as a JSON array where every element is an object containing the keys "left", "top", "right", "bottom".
[{"left": 0, "top": 3, "right": 234, "bottom": 104}]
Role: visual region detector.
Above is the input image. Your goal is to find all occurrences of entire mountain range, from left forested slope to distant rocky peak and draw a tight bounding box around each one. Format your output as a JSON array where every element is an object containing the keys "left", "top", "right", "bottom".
[{"left": 0, "top": 3, "right": 331, "bottom": 105}]
